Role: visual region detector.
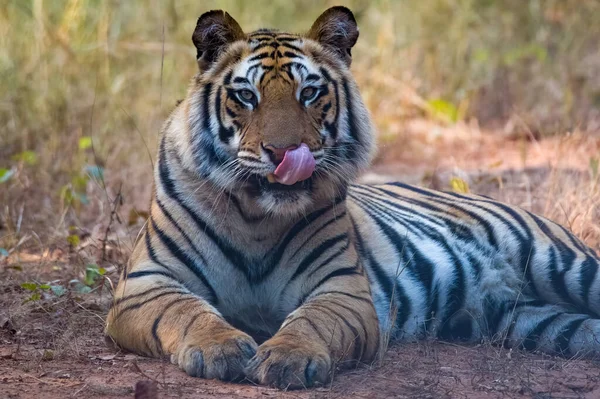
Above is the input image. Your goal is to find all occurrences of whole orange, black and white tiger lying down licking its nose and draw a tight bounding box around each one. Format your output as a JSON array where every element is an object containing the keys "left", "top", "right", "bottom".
[{"left": 105, "top": 6, "right": 600, "bottom": 389}]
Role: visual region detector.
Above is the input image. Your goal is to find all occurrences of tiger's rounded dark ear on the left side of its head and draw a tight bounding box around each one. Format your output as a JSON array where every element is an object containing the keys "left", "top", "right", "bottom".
[{"left": 192, "top": 10, "right": 246, "bottom": 72}]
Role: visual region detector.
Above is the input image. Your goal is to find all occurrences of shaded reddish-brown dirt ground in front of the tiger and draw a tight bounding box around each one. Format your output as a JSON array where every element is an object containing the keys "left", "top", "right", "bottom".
[{"left": 0, "top": 264, "right": 600, "bottom": 399}]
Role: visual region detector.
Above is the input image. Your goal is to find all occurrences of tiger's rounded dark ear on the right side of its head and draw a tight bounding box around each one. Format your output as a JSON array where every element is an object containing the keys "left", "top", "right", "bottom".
[{"left": 308, "top": 6, "right": 358, "bottom": 66}]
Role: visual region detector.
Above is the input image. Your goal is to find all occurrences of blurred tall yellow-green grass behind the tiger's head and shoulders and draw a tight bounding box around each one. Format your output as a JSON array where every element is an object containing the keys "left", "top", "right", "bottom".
[{"left": 0, "top": 0, "right": 600, "bottom": 247}]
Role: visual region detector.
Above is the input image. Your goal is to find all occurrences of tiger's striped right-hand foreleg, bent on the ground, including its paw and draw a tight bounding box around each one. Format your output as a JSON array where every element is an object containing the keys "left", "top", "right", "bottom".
[{"left": 247, "top": 267, "right": 379, "bottom": 389}]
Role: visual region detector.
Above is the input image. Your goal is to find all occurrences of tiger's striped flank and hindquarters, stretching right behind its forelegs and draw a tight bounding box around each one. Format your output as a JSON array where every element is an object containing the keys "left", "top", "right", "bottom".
[{"left": 349, "top": 183, "right": 600, "bottom": 355}]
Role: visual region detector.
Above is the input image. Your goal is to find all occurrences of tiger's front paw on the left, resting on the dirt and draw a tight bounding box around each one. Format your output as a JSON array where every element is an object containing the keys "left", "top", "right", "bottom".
[{"left": 171, "top": 329, "right": 257, "bottom": 381}]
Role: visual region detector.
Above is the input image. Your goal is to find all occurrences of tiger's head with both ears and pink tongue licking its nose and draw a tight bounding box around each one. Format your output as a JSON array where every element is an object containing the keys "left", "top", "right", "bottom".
[{"left": 175, "top": 7, "right": 374, "bottom": 216}]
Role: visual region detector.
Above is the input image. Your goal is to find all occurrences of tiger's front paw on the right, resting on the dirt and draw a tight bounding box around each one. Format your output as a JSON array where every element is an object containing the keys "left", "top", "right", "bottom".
[{"left": 246, "top": 336, "right": 331, "bottom": 389}]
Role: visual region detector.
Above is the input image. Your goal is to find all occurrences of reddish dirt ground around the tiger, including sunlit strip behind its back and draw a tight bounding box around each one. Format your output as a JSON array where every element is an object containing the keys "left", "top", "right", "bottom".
[{"left": 0, "top": 125, "right": 600, "bottom": 399}]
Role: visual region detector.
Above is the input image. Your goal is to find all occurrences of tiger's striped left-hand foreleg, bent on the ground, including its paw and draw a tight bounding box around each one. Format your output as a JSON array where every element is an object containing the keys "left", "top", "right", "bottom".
[{"left": 106, "top": 264, "right": 257, "bottom": 380}]
